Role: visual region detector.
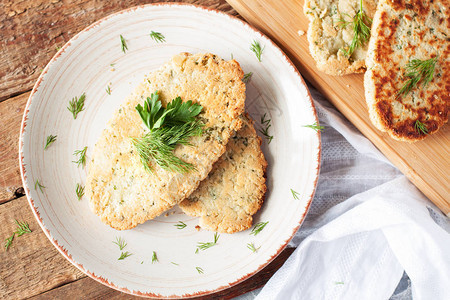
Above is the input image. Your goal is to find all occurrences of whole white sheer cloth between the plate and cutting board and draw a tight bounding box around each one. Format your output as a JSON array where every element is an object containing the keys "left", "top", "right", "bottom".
[{"left": 239, "top": 87, "right": 450, "bottom": 300}]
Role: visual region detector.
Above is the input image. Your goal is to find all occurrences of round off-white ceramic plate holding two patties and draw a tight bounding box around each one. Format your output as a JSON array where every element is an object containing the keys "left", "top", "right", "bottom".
[{"left": 20, "top": 4, "right": 320, "bottom": 298}]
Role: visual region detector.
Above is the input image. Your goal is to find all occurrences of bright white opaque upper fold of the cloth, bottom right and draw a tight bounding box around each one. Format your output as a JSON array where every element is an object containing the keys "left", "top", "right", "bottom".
[{"left": 257, "top": 176, "right": 450, "bottom": 299}]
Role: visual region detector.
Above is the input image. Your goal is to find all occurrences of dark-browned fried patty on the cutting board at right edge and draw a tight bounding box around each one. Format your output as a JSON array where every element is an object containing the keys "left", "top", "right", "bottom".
[{"left": 364, "top": 0, "right": 450, "bottom": 142}]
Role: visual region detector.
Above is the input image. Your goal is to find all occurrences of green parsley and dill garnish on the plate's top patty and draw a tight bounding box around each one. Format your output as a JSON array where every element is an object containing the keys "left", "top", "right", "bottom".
[{"left": 132, "top": 91, "right": 203, "bottom": 173}]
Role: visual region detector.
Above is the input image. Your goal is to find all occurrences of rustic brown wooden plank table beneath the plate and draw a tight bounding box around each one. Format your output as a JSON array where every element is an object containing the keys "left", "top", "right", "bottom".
[{"left": 0, "top": 0, "right": 293, "bottom": 299}]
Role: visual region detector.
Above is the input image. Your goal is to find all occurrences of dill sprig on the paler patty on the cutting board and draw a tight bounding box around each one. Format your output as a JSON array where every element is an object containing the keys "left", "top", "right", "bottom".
[{"left": 339, "top": 0, "right": 372, "bottom": 57}]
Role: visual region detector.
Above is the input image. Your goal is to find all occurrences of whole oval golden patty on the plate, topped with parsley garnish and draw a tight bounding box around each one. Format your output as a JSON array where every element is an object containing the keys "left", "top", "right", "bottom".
[{"left": 86, "top": 53, "right": 245, "bottom": 230}]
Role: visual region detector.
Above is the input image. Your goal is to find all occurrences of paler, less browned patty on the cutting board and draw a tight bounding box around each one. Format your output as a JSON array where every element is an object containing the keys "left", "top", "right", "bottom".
[{"left": 303, "top": 0, "right": 377, "bottom": 75}]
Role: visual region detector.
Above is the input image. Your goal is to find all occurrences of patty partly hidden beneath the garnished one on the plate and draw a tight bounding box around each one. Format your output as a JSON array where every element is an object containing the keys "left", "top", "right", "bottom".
[{"left": 179, "top": 116, "right": 267, "bottom": 233}]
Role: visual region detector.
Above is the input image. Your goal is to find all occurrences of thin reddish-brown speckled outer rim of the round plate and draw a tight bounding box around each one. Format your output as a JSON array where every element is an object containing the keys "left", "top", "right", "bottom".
[{"left": 19, "top": 2, "right": 322, "bottom": 299}]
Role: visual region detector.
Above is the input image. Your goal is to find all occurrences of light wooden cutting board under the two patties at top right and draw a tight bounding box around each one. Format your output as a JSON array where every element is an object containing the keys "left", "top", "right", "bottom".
[{"left": 227, "top": 0, "right": 450, "bottom": 216}]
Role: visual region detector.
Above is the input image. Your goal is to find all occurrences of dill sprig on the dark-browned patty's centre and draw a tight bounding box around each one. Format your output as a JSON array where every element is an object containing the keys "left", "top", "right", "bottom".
[{"left": 397, "top": 57, "right": 437, "bottom": 98}]
